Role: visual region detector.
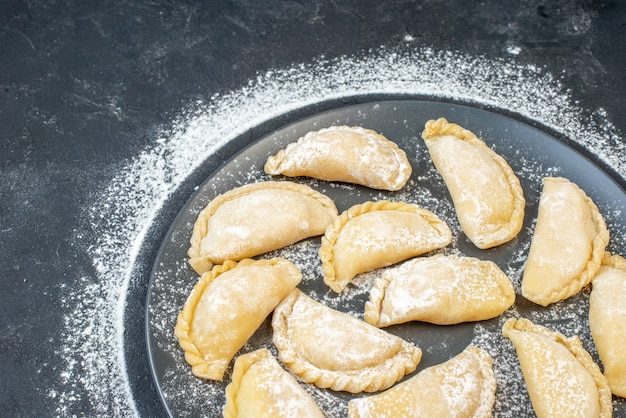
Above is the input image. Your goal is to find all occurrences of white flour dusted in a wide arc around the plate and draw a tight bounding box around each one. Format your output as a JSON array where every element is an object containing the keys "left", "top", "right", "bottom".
[{"left": 56, "top": 48, "right": 626, "bottom": 416}]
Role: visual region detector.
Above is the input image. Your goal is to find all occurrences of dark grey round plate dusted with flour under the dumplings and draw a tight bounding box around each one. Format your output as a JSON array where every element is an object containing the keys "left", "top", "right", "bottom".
[{"left": 146, "top": 100, "right": 626, "bottom": 416}]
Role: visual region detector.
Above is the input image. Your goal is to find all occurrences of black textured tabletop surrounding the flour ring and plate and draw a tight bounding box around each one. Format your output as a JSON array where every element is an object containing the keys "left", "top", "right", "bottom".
[{"left": 0, "top": 0, "right": 626, "bottom": 416}]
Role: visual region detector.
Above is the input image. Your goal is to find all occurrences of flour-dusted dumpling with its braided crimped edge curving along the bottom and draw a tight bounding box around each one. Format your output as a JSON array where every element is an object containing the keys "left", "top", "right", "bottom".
[{"left": 272, "top": 289, "right": 422, "bottom": 393}]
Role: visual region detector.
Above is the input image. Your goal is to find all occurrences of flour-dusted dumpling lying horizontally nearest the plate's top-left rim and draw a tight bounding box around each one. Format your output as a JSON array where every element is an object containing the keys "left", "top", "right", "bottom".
[{"left": 265, "top": 126, "right": 412, "bottom": 190}]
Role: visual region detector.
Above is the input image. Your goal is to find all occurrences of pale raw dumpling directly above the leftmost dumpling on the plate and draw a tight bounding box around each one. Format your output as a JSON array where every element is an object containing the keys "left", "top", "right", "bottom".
[{"left": 187, "top": 181, "right": 337, "bottom": 274}]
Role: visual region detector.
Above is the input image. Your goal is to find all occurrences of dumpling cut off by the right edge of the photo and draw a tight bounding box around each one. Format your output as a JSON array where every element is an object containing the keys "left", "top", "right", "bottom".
[{"left": 589, "top": 251, "right": 626, "bottom": 398}]
